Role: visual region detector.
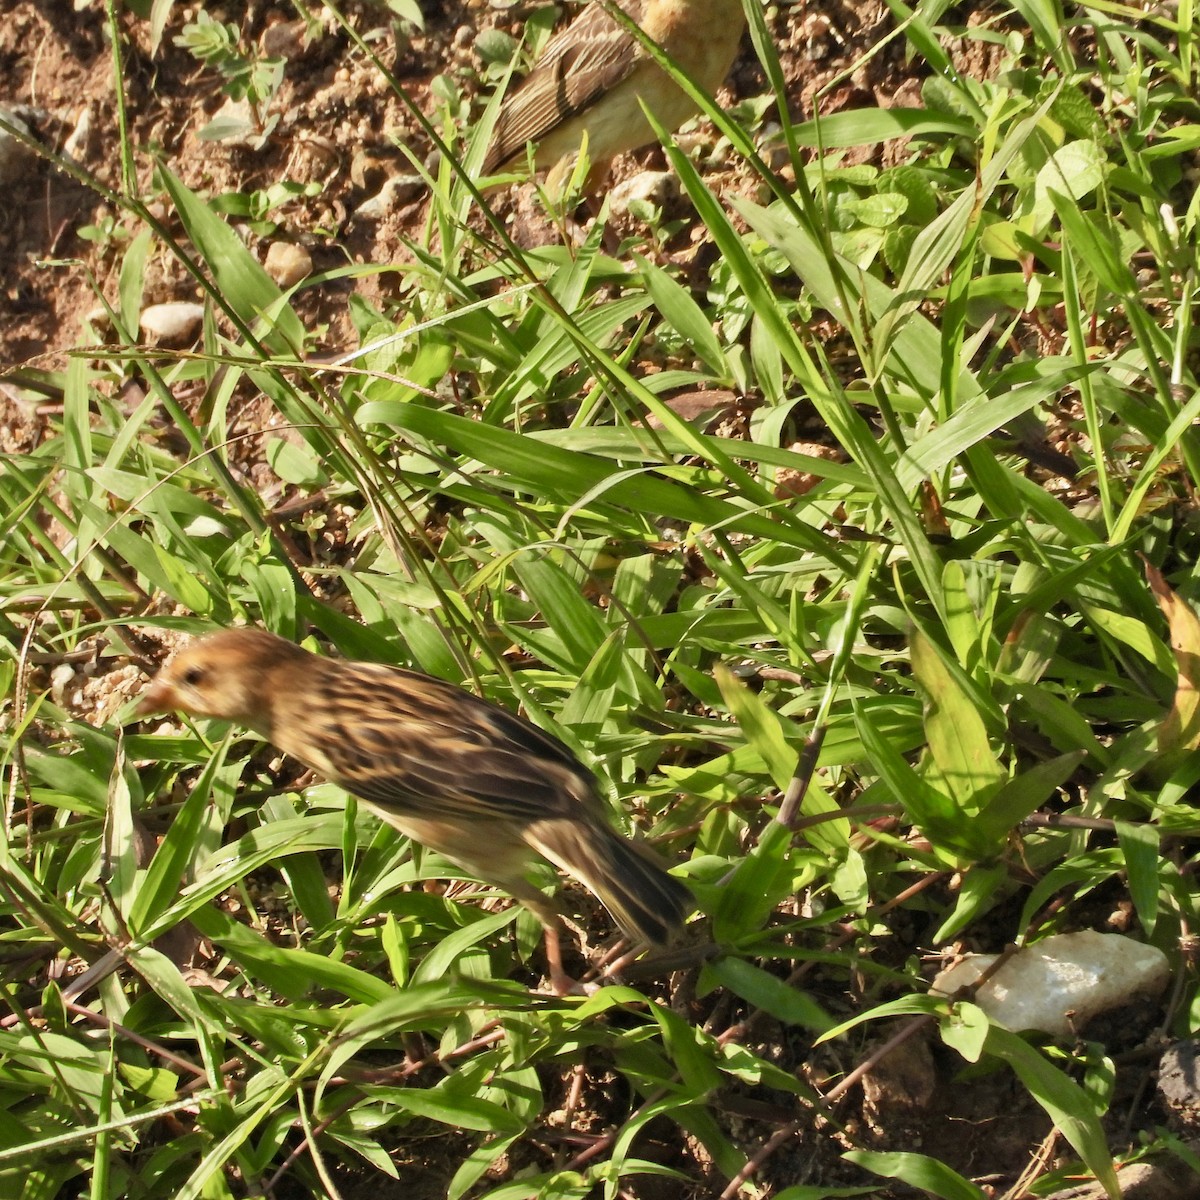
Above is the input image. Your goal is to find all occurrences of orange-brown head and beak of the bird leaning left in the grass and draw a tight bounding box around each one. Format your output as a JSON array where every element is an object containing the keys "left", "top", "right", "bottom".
[{"left": 134, "top": 629, "right": 297, "bottom": 732}]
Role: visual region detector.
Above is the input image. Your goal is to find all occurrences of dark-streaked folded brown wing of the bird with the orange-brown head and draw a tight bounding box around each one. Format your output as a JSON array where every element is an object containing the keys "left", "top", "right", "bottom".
[{"left": 300, "top": 664, "right": 601, "bottom": 830}]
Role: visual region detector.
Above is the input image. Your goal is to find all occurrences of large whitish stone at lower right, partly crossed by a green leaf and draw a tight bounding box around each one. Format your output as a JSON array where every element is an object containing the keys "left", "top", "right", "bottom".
[{"left": 930, "top": 930, "right": 1171, "bottom": 1037}]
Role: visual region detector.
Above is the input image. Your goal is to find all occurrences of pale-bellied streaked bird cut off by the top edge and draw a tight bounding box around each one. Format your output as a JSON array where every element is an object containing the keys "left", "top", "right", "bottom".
[{"left": 482, "top": 0, "right": 745, "bottom": 192}]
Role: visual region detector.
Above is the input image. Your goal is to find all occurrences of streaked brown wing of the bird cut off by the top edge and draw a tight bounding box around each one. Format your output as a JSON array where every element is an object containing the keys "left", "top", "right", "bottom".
[{"left": 484, "top": 0, "right": 647, "bottom": 174}]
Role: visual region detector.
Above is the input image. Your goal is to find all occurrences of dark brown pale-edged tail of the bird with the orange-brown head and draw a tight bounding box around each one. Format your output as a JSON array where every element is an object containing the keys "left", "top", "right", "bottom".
[{"left": 526, "top": 821, "right": 695, "bottom": 946}]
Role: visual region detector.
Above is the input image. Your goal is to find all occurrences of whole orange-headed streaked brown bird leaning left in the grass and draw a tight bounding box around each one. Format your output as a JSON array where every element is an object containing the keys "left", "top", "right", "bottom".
[{"left": 137, "top": 629, "right": 691, "bottom": 995}]
